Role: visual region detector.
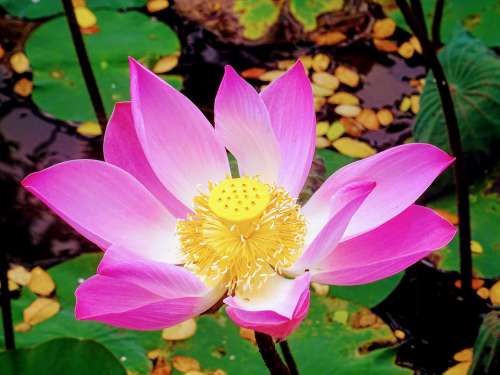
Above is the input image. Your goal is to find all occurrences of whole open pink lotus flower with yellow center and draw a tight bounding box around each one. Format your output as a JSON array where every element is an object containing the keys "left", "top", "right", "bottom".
[{"left": 22, "top": 60, "right": 455, "bottom": 337}]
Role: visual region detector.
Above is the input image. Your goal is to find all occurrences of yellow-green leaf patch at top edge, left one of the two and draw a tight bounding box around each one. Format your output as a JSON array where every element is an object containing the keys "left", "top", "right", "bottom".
[{"left": 234, "top": 0, "right": 280, "bottom": 40}]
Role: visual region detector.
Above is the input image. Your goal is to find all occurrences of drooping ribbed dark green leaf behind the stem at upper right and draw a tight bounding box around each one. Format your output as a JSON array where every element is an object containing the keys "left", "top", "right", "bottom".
[{"left": 414, "top": 31, "right": 500, "bottom": 185}]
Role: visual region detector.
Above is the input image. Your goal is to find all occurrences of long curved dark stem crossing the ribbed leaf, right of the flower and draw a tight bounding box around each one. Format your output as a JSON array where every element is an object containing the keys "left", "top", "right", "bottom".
[{"left": 396, "top": 0, "right": 472, "bottom": 300}]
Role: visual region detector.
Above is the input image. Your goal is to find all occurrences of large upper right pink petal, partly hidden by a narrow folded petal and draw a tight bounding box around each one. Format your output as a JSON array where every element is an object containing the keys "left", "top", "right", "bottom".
[{"left": 303, "top": 143, "right": 454, "bottom": 238}]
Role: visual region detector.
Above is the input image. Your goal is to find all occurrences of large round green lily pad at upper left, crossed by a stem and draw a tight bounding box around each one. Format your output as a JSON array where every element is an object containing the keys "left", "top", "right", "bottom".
[{"left": 26, "top": 10, "right": 181, "bottom": 121}]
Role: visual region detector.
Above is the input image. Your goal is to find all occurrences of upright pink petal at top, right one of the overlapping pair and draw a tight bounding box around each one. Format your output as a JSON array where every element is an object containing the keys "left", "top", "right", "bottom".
[{"left": 260, "top": 61, "right": 316, "bottom": 197}]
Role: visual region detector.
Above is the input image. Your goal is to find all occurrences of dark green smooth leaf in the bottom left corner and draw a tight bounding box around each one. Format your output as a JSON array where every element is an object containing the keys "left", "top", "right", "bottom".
[{"left": 0, "top": 338, "right": 126, "bottom": 375}]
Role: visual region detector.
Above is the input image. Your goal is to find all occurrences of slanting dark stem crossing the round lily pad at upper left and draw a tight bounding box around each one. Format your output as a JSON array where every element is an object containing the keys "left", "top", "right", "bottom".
[{"left": 62, "top": 0, "right": 108, "bottom": 129}]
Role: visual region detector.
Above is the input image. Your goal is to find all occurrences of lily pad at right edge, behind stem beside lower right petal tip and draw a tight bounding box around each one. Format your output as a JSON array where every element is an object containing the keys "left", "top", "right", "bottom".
[{"left": 429, "top": 182, "right": 500, "bottom": 278}]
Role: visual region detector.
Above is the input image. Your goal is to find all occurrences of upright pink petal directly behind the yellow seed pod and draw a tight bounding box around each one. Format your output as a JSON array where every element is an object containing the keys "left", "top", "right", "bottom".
[{"left": 215, "top": 66, "right": 280, "bottom": 183}]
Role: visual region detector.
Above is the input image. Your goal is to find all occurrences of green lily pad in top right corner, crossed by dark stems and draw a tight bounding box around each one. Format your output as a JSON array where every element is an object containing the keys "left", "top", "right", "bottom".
[{"left": 384, "top": 0, "right": 500, "bottom": 46}]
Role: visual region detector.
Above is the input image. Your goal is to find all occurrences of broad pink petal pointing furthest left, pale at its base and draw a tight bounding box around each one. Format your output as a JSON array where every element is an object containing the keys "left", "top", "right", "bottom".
[{"left": 22, "top": 160, "right": 179, "bottom": 262}]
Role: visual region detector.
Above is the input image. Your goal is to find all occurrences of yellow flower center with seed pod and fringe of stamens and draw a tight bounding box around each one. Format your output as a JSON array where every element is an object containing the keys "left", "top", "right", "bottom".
[{"left": 177, "top": 176, "right": 305, "bottom": 293}]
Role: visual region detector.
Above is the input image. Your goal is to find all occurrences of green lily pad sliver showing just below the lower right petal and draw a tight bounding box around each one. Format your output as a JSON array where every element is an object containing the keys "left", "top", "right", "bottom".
[{"left": 330, "top": 272, "right": 404, "bottom": 308}]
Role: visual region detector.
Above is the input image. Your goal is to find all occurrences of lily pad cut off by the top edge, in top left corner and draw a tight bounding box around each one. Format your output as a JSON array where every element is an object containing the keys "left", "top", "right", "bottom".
[{"left": 0, "top": 0, "right": 146, "bottom": 19}]
